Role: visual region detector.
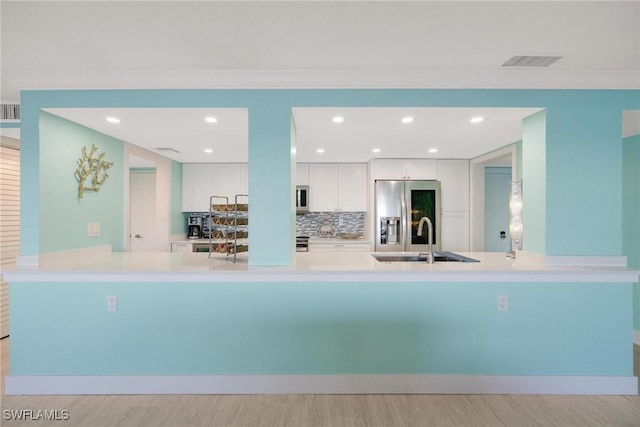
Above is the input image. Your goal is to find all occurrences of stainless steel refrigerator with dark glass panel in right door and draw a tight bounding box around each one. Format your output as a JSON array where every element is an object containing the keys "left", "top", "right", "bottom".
[{"left": 374, "top": 180, "right": 440, "bottom": 252}]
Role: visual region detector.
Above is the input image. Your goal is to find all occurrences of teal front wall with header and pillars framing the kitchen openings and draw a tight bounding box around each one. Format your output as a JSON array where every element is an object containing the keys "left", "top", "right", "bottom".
[{"left": 21, "top": 89, "right": 640, "bottom": 265}]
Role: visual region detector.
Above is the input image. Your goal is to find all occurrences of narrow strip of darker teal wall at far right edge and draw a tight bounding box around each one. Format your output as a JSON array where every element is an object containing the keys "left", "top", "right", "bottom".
[{"left": 622, "top": 135, "right": 640, "bottom": 332}]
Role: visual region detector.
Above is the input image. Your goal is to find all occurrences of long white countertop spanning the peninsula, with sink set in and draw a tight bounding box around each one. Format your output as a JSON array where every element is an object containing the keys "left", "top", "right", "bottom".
[{"left": 2, "top": 247, "right": 639, "bottom": 283}]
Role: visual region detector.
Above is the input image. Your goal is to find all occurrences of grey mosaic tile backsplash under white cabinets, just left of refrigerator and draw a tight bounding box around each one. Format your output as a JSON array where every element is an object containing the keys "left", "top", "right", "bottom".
[{"left": 296, "top": 212, "right": 366, "bottom": 237}]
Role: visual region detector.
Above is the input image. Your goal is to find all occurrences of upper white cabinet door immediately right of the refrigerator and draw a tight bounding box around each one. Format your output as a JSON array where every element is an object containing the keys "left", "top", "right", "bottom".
[{"left": 438, "top": 160, "right": 469, "bottom": 212}]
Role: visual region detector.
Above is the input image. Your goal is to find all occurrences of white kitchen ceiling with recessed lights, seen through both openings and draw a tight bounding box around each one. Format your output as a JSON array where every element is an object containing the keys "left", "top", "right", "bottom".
[{"left": 46, "top": 108, "right": 539, "bottom": 163}]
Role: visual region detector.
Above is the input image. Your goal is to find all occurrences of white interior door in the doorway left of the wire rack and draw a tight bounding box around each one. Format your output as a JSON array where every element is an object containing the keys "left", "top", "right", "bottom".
[{"left": 129, "top": 170, "right": 158, "bottom": 252}]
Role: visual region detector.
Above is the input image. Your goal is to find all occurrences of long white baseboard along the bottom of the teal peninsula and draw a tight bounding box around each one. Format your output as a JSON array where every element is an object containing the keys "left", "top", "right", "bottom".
[{"left": 5, "top": 375, "right": 638, "bottom": 396}]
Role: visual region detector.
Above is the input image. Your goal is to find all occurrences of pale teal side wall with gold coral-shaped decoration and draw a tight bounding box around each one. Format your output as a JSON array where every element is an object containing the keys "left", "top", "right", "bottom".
[{"left": 38, "top": 112, "right": 124, "bottom": 253}]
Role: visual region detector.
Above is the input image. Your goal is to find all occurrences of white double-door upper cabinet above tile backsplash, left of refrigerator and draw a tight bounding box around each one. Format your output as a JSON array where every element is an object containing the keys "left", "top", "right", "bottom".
[{"left": 309, "top": 163, "right": 367, "bottom": 212}]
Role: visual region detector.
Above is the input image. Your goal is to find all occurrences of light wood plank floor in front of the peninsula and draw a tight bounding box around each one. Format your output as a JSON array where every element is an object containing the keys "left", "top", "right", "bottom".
[{"left": 0, "top": 339, "right": 640, "bottom": 427}]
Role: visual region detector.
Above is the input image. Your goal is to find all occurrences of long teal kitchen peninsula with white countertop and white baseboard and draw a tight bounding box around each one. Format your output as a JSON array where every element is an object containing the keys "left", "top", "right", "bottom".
[{"left": 3, "top": 251, "right": 638, "bottom": 394}]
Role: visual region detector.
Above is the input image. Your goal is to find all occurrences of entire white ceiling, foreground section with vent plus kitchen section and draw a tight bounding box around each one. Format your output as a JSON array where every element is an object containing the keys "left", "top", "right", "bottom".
[{"left": 0, "top": 0, "right": 640, "bottom": 162}]
